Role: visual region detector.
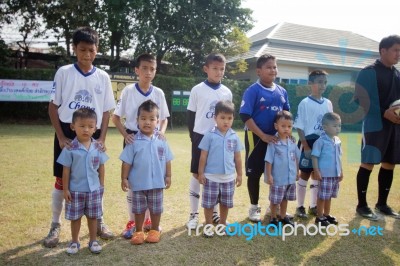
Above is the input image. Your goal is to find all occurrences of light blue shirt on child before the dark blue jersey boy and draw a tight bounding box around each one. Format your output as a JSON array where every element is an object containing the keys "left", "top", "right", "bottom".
[{"left": 264, "top": 138, "right": 300, "bottom": 186}]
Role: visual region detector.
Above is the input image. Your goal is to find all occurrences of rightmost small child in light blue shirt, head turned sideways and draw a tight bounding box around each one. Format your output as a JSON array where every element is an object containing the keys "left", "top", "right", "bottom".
[{"left": 311, "top": 112, "right": 343, "bottom": 226}]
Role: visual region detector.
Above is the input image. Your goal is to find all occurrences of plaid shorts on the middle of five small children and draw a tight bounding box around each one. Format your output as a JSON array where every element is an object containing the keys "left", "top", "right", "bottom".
[{"left": 201, "top": 178, "right": 235, "bottom": 209}]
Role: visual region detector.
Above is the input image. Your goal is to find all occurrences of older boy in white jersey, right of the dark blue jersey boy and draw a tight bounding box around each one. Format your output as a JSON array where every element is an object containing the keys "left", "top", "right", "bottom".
[{"left": 294, "top": 70, "right": 332, "bottom": 218}]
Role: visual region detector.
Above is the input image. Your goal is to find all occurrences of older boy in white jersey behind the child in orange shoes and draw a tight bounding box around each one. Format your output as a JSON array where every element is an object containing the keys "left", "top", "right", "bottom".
[{"left": 112, "top": 54, "right": 169, "bottom": 239}]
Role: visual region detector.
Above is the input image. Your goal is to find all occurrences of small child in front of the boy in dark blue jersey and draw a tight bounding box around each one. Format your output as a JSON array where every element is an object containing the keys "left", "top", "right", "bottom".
[{"left": 264, "top": 110, "right": 300, "bottom": 226}]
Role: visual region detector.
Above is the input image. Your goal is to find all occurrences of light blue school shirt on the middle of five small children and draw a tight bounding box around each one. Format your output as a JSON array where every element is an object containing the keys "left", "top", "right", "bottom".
[{"left": 199, "top": 127, "right": 243, "bottom": 174}]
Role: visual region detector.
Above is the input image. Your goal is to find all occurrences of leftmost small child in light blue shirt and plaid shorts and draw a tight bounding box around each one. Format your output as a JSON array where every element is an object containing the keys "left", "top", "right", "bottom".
[{"left": 57, "top": 108, "right": 108, "bottom": 254}]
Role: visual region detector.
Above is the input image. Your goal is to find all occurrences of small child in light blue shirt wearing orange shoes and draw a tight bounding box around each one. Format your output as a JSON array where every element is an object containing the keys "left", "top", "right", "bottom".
[{"left": 120, "top": 100, "right": 173, "bottom": 245}]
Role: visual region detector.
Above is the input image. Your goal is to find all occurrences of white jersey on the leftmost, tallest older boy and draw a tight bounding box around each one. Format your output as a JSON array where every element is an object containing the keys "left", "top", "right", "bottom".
[{"left": 50, "top": 64, "right": 115, "bottom": 128}]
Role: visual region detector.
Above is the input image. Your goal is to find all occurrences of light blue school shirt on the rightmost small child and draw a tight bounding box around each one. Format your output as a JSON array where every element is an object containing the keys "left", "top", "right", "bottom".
[{"left": 311, "top": 133, "right": 342, "bottom": 177}]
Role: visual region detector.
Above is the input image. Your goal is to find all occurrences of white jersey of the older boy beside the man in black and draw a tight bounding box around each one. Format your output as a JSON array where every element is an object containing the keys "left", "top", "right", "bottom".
[{"left": 294, "top": 96, "right": 333, "bottom": 136}]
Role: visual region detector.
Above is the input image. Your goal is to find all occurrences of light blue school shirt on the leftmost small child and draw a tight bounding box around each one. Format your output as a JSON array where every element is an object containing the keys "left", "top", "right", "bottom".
[{"left": 57, "top": 138, "right": 108, "bottom": 192}]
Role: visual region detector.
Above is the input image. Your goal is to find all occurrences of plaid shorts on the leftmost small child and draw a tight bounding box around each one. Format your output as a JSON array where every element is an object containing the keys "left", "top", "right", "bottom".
[{"left": 65, "top": 188, "right": 104, "bottom": 221}]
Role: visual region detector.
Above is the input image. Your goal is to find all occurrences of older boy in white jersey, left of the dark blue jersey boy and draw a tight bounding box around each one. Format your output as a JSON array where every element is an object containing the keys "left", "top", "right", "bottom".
[{"left": 186, "top": 53, "right": 232, "bottom": 230}]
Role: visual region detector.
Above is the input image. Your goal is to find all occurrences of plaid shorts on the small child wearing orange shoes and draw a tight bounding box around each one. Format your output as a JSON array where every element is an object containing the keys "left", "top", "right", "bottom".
[{"left": 132, "top": 188, "right": 164, "bottom": 214}]
